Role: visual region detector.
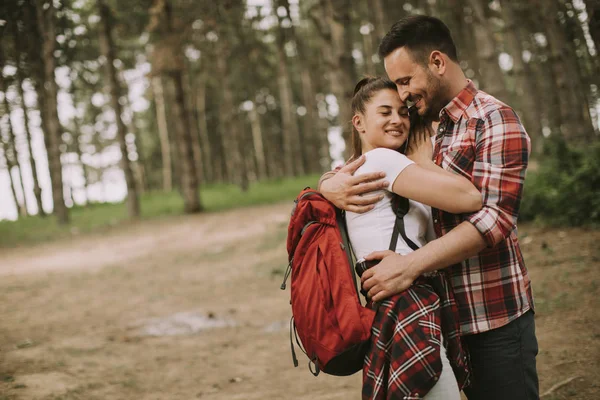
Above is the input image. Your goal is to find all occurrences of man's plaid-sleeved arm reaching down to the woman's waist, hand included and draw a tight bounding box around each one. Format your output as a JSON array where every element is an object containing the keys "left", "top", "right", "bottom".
[{"left": 361, "top": 108, "right": 530, "bottom": 301}]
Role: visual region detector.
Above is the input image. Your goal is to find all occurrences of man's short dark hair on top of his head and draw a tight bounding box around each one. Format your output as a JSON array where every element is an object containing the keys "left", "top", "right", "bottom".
[{"left": 379, "top": 15, "right": 458, "bottom": 64}]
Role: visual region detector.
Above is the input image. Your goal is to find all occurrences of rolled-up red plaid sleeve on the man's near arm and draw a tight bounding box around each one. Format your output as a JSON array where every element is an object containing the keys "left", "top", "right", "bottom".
[{"left": 467, "top": 107, "right": 531, "bottom": 247}]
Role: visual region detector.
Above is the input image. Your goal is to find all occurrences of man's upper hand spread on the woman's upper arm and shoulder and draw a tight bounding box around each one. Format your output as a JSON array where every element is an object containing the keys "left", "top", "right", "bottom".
[{"left": 319, "top": 156, "right": 389, "bottom": 213}]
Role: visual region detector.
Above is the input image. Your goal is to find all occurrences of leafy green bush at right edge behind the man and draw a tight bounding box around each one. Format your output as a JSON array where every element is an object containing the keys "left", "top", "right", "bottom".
[{"left": 519, "top": 138, "right": 600, "bottom": 227}]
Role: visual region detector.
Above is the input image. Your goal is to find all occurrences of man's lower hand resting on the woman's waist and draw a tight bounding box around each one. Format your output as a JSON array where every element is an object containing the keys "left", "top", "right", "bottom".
[{"left": 360, "top": 250, "right": 420, "bottom": 302}]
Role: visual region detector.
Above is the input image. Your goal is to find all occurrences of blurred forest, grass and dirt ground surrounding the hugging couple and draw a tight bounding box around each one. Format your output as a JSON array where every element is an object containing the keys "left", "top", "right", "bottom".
[{"left": 0, "top": 0, "right": 600, "bottom": 400}]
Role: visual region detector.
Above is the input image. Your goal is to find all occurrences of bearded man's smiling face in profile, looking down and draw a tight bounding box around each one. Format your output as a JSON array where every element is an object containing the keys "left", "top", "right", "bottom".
[{"left": 384, "top": 47, "right": 448, "bottom": 120}]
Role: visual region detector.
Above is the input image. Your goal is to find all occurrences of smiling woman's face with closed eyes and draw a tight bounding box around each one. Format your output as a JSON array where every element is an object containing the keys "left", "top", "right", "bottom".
[{"left": 352, "top": 89, "right": 410, "bottom": 153}]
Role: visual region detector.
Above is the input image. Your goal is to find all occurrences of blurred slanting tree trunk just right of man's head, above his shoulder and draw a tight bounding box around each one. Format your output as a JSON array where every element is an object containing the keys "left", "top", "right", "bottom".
[{"left": 468, "top": 0, "right": 508, "bottom": 101}]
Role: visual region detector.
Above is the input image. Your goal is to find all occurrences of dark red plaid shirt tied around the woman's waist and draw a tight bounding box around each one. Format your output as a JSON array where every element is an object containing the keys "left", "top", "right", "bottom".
[{"left": 362, "top": 272, "right": 469, "bottom": 400}]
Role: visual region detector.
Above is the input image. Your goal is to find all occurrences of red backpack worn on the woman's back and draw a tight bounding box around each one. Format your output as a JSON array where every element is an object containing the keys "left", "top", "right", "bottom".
[{"left": 281, "top": 188, "right": 375, "bottom": 376}]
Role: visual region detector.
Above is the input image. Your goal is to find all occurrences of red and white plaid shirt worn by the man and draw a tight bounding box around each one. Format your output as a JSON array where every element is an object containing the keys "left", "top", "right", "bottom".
[{"left": 433, "top": 81, "right": 533, "bottom": 335}]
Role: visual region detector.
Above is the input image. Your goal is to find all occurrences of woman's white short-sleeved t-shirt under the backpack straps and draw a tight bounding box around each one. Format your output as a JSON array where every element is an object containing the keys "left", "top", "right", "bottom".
[{"left": 346, "top": 148, "right": 435, "bottom": 259}]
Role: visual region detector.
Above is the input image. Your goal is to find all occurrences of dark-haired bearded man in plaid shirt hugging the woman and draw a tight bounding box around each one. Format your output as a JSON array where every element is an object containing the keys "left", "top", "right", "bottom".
[{"left": 320, "top": 16, "right": 539, "bottom": 400}]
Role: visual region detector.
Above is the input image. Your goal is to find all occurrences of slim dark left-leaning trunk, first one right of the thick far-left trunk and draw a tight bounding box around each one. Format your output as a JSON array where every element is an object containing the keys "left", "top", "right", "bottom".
[{"left": 98, "top": 0, "right": 140, "bottom": 218}]
